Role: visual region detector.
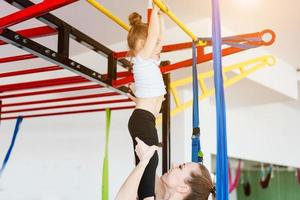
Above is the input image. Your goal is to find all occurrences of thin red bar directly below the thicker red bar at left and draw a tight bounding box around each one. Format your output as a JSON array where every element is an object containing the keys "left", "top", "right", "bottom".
[{"left": 0, "top": 84, "right": 103, "bottom": 99}]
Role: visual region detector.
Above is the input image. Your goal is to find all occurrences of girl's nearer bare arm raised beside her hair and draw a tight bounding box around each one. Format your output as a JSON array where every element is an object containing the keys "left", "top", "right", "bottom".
[{"left": 139, "top": 4, "right": 160, "bottom": 59}]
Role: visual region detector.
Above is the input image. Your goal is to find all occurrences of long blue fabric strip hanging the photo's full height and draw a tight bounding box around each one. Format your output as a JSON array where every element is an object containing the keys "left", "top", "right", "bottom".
[{"left": 212, "top": 0, "right": 229, "bottom": 200}]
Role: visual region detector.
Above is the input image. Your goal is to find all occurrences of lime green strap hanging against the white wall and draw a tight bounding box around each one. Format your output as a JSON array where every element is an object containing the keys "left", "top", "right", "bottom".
[{"left": 102, "top": 108, "right": 111, "bottom": 200}]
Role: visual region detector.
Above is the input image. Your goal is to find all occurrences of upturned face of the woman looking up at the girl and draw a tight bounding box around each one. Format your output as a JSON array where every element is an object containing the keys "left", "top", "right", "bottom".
[{"left": 161, "top": 162, "right": 200, "bottom": 188}]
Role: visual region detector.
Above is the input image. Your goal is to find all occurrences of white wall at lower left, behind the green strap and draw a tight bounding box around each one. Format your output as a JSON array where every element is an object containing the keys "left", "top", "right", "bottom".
[{"left": 0, "top": 111, "right": 134, "bottom": 200}]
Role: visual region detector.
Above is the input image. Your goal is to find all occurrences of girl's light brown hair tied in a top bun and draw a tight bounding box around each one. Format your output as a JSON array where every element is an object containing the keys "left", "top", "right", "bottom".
[{"left": 127, "top": 12, "right": 148, "bottom": 56}]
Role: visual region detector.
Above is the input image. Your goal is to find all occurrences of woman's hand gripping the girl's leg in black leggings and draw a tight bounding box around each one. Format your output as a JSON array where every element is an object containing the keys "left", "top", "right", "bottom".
[{"left": 135, "top": 137, "right": 158, "bottom": 162}]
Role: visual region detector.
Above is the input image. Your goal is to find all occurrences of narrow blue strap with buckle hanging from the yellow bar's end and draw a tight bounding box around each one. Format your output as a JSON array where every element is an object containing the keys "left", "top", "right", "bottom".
[{"left": 192, "top": 42, "right": 203, "bottom": 163}]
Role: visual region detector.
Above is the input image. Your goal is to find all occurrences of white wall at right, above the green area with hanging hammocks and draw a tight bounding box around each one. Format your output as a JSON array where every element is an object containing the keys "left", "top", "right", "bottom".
[{"left": 179, "top": 84, "right": 300, "bottom": 167}]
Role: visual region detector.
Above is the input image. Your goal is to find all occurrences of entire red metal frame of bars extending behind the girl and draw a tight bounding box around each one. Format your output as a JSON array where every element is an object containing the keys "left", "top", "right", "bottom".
[{"left": 0, "top": 0, "right": 275, "bottom": 120}]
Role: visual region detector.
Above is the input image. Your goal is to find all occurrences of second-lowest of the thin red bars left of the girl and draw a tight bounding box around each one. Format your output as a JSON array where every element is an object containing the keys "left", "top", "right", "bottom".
[{"left": 0, "top": 99, "right": 131, "bottom": 114}]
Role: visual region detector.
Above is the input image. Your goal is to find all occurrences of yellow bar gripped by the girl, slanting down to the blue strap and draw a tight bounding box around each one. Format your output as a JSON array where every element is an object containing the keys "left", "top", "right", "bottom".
[{"left": 153, "top": 0, "right": 206, "bottom": 46}]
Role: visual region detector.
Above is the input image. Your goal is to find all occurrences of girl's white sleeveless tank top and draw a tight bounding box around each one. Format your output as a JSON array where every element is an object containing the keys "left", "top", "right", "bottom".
[{"left": 133, "top": 55, "right": 166, "bottom": 98}]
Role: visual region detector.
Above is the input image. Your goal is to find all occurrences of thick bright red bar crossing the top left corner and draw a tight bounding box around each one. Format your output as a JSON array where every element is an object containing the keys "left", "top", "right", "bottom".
[{"left": 0, "top": 0, "right": 77, "bottom": 29}]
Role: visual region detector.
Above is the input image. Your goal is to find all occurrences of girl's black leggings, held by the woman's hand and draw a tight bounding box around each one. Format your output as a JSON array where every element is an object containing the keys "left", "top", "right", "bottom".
[{"left": 128, "top": 109, "right": 158, "bottom": 200}]
